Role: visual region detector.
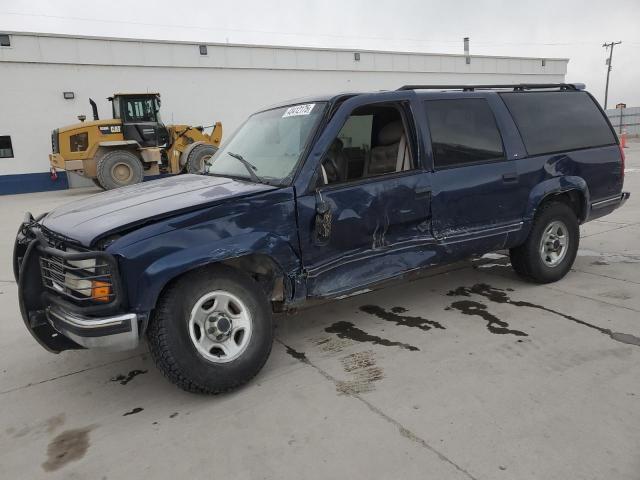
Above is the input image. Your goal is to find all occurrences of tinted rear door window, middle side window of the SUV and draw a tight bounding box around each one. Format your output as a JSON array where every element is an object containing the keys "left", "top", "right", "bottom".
[{"left": 425, "top": 98, "right": 504, "bottom": 168}]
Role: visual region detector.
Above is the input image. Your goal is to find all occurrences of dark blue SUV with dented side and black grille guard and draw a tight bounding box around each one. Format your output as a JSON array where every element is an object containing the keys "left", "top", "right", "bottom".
[{"left": 14, "top": 84, "right": 629, "bottom": 393}]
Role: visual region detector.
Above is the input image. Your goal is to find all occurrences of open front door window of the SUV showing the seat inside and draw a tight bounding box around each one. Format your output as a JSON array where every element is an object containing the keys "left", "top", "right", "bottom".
[{"left": 319, "top": 104, "right": 414, "bottom": 185}]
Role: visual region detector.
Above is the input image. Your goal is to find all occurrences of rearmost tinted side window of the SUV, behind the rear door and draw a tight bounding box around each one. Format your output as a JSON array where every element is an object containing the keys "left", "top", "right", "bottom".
[{"left": 501, "top": 92, "right": 616, "bottom": 155}]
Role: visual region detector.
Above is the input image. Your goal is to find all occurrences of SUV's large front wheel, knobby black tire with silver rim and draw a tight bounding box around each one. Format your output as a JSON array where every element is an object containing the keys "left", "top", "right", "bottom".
[{"left": 147, "top": 266, "right": 273, "bottom": 394}]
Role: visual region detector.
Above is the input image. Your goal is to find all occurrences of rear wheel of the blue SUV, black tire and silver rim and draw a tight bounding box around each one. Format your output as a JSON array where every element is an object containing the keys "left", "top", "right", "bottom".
[{"left": 509, "top": 201, "right": 580, "bottom": 283}]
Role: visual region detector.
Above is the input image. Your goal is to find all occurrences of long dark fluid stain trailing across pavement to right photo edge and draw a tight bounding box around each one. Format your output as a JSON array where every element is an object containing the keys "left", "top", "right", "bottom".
[{"left": 447, "top": 283, "right": 640, "bottom": 347}]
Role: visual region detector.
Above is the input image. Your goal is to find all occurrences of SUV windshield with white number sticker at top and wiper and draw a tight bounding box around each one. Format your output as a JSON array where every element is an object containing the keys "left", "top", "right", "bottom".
[{"left": 208, "top": 102, "right": 326, "bottom": 184}]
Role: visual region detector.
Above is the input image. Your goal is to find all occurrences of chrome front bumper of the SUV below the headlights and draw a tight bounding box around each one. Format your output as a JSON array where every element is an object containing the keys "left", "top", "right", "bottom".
[{"left": 46, "top": 306, "right": 139, "bottom": 350}]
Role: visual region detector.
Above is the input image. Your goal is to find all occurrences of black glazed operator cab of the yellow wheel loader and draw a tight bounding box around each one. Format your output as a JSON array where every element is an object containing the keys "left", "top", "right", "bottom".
[{"left": 109, "top": 93, "right": 169, "bottom": 147}]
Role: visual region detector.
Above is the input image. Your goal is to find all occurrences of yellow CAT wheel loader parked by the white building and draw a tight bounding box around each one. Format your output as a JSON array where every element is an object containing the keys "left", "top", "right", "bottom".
[{"left": 49, "top": 93, "right": 222, "bottom": 190}]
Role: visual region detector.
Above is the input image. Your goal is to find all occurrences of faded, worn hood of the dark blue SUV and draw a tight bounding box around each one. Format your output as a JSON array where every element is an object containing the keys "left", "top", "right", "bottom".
[{"left": 41, "top": 175, "right": 276, "bottom": 246}]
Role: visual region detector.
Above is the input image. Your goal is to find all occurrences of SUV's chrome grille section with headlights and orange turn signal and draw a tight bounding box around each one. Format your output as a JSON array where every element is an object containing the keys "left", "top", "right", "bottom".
[{"left": 40, "top": 251, "right": 115, "bottom": 305}]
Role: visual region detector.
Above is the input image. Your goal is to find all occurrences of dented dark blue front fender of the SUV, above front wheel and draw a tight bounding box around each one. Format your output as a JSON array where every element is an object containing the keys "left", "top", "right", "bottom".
[{"left": 113, "top": 188, "right": 300, "bottom": 312}]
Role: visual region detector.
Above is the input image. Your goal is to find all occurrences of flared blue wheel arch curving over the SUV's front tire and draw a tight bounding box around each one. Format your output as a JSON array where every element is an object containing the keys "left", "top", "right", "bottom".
[{"left": 129, "top": 232, "right": 300, "bottom": 312}]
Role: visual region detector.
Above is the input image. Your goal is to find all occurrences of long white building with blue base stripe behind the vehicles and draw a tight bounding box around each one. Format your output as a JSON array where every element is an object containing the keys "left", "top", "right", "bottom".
[{"left": 0, "top": 32, "right": 568, "bottom": 194}]
